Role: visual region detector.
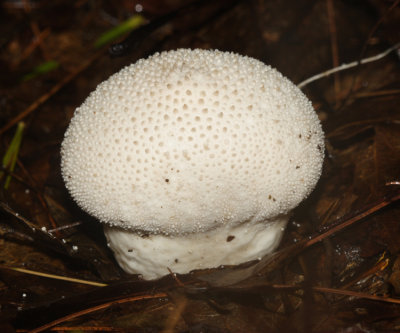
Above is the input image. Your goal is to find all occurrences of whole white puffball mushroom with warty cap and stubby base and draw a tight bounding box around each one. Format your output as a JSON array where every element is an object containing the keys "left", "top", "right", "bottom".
[{"left": 61, "top": 49, "right": 324, "bottom": 279}]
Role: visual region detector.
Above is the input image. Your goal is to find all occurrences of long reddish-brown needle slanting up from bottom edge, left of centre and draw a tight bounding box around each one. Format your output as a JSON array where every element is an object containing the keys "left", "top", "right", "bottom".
[{"left": 28, "top": 293, "right": 168, "bottom": 333}]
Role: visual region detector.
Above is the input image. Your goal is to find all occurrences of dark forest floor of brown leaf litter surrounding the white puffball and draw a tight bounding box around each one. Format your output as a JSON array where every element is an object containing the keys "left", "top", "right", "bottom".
[{"left": 0, "top": 0, "right": 400, "bottom": 333}]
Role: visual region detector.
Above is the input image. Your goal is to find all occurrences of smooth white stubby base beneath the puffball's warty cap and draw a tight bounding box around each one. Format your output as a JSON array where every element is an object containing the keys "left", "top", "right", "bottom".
[{"left": 104, "top": 216, "right": 288, "bottom": 280}]
